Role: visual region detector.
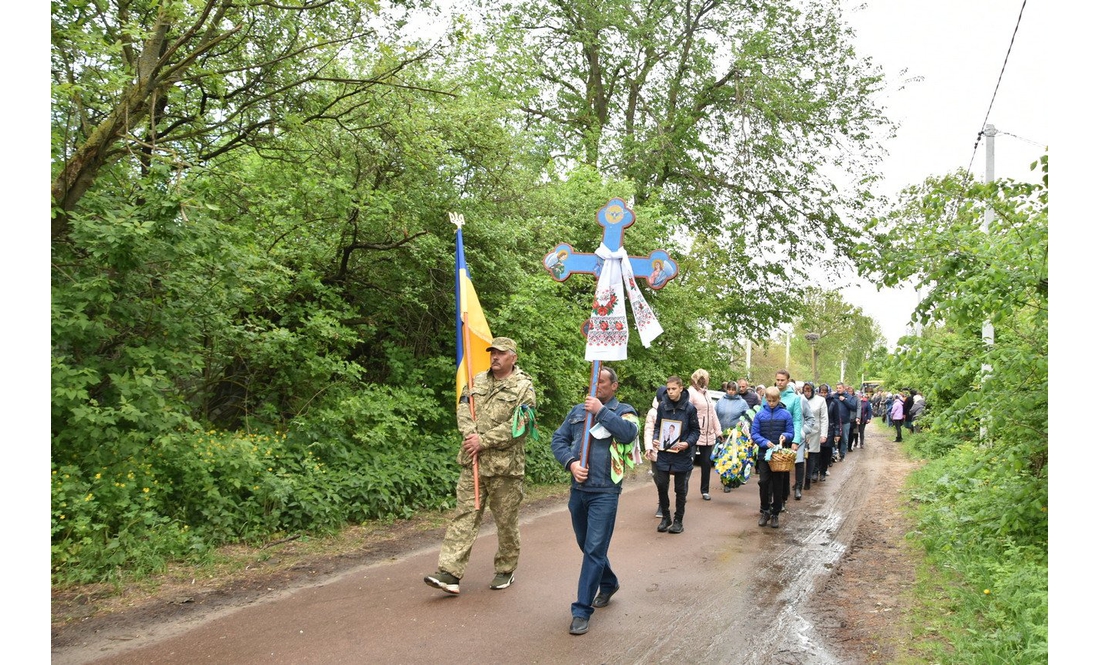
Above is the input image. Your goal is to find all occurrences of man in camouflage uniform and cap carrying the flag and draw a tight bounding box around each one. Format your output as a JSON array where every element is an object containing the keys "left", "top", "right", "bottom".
[{"left": 424, "top": 337, "right": 535, "bottom": 594}]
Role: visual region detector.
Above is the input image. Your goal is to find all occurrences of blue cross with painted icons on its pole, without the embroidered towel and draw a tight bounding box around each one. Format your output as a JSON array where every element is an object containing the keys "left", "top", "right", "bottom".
[{"left": 542, "top": 199, "right": 680, "bottom": 468}]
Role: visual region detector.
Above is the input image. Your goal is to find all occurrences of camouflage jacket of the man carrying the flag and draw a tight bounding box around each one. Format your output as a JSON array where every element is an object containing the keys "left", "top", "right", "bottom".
[{"left": 457, "top": 366, "right": 535, "bottom": 477}]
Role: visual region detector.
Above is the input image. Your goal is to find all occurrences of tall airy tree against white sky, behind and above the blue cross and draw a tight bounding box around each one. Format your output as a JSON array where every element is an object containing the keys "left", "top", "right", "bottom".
[{"left": 477, "top": 0, "right": 889, "bottom": 276}]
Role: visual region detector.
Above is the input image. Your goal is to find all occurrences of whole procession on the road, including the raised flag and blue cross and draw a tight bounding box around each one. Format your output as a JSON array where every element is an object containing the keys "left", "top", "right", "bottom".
[{"left": 424, "top": 199, "right": 924, "bottom": 635}]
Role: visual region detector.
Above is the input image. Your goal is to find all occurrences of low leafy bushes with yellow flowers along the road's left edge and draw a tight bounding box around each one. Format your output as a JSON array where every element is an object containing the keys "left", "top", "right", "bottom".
[{"left": 52, "top": 373, "right": 564, "bottom": 583}]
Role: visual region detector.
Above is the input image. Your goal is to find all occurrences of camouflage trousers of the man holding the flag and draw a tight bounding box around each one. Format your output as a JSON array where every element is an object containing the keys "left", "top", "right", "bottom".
[{"left": 439, "top": 467, "right": 524, "bottom": 579}]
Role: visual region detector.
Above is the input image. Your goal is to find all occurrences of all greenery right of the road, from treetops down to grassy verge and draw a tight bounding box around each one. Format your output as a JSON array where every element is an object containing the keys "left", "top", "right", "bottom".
[{"left": 859, "top": 156, "right": 1049, "bottom": 663}]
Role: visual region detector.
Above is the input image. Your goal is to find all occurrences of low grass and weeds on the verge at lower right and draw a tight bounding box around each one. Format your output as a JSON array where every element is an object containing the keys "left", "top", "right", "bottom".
[{"left": 909, "top": 436, "right": 1048, "bottom": 663}]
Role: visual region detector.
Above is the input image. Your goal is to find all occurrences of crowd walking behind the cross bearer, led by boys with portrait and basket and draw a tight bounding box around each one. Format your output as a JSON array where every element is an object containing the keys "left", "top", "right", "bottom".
[{"left": 642, "top": 369, "right": 924, "bottom": 533}]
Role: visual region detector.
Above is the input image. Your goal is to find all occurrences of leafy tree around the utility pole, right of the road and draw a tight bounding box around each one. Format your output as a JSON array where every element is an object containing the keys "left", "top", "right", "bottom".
[{"left": 861, "top": 156, "right": 1048, "bottom": 452}]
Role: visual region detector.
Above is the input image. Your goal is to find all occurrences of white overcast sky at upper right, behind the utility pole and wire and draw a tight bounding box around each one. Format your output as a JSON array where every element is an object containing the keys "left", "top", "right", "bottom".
[{"left": 844, "top": 0, "right": 1042, "bottom": 348}]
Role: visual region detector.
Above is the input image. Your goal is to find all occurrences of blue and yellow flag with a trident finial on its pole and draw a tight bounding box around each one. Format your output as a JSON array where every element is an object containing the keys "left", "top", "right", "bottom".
[{"left": 451, "top": 213, "right": 493, "bottom": 408}]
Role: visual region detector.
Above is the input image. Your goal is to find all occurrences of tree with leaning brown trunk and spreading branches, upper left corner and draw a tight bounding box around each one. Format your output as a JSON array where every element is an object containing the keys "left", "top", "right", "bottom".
[{"left": 51, "top": 0, "right": 422, "bottom": 239}]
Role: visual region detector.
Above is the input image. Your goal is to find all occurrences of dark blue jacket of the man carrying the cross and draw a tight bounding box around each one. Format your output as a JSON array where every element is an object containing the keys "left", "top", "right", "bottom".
[{"left": 550, "top": 397, "right": 638, "bottom": 494}]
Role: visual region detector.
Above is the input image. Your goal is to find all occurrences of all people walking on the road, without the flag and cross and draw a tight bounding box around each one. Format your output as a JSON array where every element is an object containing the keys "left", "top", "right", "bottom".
[{"left": 424, "top": 337, "right": 924, "bottom": 635}]
